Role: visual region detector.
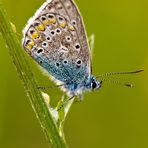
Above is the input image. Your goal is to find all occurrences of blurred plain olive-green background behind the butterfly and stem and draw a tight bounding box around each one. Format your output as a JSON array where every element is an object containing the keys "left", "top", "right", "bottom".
[{"left": 0, "top": 0, "right": 148, "bottom": 148}]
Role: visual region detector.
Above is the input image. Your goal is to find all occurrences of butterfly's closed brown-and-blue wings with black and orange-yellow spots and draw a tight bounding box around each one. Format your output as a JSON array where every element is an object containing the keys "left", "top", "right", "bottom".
[{"left": 23, "top": 0, "right": 91, "bottom": 84}]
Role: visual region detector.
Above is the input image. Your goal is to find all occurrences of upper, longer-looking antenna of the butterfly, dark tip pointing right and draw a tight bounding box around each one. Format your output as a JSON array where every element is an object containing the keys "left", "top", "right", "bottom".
[{"left": 97, "top": 69, "right": 144, "bottom": 78}]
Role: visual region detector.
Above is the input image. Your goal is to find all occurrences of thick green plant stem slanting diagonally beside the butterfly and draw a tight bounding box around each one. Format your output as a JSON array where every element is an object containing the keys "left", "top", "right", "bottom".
[{"left": 0, "top": 3, "right": 67, "bottom": 148}]
